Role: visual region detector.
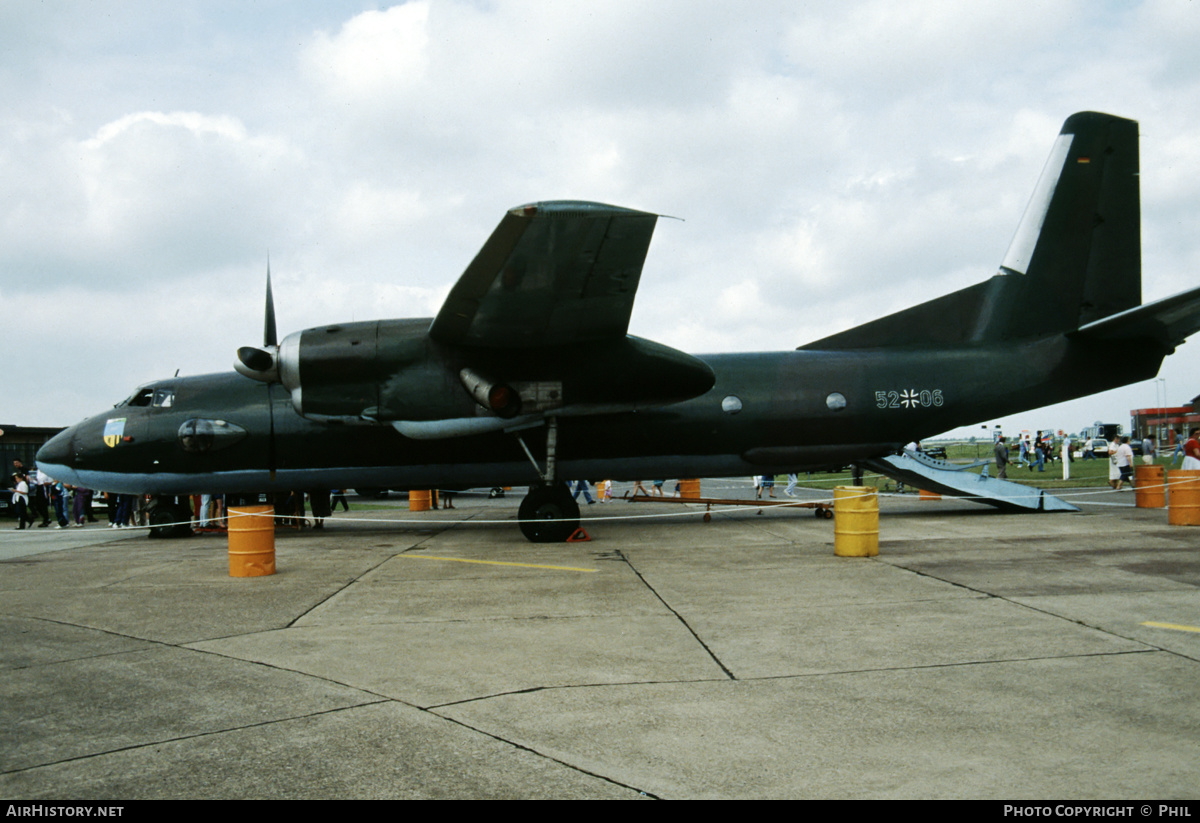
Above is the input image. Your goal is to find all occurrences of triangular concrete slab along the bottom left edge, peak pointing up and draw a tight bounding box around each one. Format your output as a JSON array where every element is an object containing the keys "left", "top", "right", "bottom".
[{"left": 0, "top": 703, "right": 642, "bottom": 801}]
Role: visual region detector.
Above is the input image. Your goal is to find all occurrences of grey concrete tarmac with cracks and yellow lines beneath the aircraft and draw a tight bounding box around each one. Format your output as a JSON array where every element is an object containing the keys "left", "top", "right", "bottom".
[{"left": 0, "top": 481, "right": 1200, "bottom": 800}]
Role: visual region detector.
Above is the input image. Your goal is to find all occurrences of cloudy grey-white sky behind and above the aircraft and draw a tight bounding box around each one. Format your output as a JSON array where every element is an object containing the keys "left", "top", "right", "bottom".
[{"left": 0, "top": 0, "right": 1200, "bottom": 441}]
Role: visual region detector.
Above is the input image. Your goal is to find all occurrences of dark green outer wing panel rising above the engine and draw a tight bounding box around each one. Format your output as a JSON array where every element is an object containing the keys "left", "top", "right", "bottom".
[{"left": 430, "top": 200, "right": 658, "bottom": 348}]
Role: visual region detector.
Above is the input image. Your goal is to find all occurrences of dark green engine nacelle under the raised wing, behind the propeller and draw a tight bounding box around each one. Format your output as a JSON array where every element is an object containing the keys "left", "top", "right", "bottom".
[{"left": 238, "top": 319, "right": 715, "bottom": 432}]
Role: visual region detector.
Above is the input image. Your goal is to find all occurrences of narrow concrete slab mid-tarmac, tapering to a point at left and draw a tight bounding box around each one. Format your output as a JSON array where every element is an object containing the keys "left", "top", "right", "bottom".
[{"left": 192, "top": 615, "right": 726, "bottom": 707}]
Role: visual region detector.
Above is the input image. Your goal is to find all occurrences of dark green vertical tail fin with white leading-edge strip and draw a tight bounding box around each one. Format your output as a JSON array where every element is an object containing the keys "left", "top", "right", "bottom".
[{"left": 802, "top": 112, "right": 1141, "bottom": 349}]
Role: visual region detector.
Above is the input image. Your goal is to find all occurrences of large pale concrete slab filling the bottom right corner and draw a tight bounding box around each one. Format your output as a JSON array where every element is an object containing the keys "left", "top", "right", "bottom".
[{"left": 438, "top": 653, "right": 1200, "bottom": 800}]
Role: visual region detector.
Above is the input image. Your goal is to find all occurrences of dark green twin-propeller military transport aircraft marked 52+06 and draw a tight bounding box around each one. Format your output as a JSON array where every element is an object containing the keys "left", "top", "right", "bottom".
[{"left": 37, "top": 112, "right": 1200, "bottom": 541}]
